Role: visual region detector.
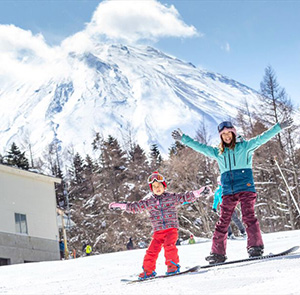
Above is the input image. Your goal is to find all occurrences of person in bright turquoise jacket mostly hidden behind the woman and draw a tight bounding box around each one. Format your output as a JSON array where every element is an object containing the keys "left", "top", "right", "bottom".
[{"left": 212, "top": 176, "right": 247, "bottom": 239}]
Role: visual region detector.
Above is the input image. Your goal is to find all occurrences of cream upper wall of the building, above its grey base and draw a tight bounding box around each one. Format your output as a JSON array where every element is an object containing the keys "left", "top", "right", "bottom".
[{"left": 0, "top": 170, "right": 58, "bottom": 240}]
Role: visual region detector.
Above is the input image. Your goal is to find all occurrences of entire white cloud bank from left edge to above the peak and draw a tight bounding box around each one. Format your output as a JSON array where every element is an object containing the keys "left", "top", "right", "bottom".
[{"left": 0, "top": 0, "right": 201, "bottom": 81}]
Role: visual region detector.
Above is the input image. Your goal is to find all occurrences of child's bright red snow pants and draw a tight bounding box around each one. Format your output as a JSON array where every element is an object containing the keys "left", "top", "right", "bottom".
[{"left": 143, "top": 228, "right": 179, "bottom": 272}]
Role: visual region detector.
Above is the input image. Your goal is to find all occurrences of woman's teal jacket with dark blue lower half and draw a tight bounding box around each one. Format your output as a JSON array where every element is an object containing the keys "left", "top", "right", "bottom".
[{"left": 181, "top": 123, "right": 281, "bottom": 196}]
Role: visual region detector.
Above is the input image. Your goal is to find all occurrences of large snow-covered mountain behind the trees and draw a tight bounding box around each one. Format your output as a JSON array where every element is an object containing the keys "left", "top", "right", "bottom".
[{"left": 0, "top": 44, "right": 257, "bottom": 164}]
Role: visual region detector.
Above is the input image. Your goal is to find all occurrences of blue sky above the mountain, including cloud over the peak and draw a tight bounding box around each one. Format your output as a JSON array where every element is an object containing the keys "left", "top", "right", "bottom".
[{"left": 0, "top": 0, "right": 300, "bottom": 105}]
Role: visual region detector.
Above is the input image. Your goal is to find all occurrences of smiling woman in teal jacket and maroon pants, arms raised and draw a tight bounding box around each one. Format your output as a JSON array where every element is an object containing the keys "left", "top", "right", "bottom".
[{"left": 172, "top": 119, "right": 293, "bottom": 264}]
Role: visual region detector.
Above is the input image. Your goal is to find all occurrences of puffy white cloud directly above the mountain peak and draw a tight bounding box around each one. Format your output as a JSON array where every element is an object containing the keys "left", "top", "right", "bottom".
[{"left": 86, "top": 0, "right": 199, "bottom": 43}]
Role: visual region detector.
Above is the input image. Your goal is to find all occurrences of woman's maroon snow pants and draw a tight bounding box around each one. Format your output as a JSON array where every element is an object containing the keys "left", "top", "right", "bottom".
[{"left": 211, "top": 192, "right": 263, "bottom": 255}]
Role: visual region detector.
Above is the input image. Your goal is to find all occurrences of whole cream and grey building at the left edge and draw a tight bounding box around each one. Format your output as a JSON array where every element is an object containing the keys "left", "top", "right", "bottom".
[{"left": 0, "top": 164, "right": 61, "bottom": 265}]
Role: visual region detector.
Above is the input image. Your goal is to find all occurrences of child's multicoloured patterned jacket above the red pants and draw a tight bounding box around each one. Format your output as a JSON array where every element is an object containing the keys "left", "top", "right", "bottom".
[{"left": 126, "top": 192, "right": 196, "bottom": 232}]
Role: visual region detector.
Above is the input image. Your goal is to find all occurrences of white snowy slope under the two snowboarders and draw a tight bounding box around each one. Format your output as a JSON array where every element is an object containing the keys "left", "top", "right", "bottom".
[{"left": 0, "top": 230, "right": 300, "bottom": 295}]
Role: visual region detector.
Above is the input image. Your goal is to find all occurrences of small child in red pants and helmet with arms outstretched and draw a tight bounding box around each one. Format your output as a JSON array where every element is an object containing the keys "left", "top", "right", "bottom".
[{"left": 109, "top": 171, "right": 212, "bottom": 280}]
